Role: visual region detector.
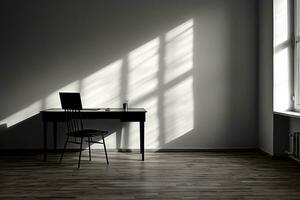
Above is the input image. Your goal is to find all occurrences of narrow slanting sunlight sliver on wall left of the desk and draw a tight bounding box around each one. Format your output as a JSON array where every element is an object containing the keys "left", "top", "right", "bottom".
[{"left": 0, "top": 101, "right": 42, "bottom": 128}]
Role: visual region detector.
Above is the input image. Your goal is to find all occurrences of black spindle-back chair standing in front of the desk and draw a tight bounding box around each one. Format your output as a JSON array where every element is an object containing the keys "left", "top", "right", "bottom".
[{"left": 59, "top": 92, "right": 109, "bottom": 168}]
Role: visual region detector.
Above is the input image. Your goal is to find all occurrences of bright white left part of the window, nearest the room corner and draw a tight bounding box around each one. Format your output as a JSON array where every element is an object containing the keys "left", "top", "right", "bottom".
[{"left": 273, "top": 0, "right": 292, "bottom": 111}]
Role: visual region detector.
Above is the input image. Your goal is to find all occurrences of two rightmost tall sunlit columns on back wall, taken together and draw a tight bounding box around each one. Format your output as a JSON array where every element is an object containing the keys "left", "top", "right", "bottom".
[{"left": 128, "top": 20, "right": 194, "bottom": 148}]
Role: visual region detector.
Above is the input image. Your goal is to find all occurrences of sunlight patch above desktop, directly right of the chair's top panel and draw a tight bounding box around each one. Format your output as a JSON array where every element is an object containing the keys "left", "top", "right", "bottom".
[{"left": 81, "top": 60, "right": 122, "bottom": 108}]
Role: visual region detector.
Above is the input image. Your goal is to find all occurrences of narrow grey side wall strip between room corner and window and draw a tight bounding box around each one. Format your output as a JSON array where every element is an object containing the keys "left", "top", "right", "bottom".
[{"left": 258, "top": 0, "right": 273, "bottom": 155}]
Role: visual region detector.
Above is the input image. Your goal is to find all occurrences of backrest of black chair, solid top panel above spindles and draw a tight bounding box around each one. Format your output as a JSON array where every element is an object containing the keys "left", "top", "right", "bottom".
[{"left": 59, "top": 92, "right": 83, "bottom": 132}]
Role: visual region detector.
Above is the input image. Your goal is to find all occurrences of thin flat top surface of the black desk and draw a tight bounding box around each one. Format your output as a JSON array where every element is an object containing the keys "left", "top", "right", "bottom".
[{"left": 41, "top": 108, "right": 147, "bottom": 112}]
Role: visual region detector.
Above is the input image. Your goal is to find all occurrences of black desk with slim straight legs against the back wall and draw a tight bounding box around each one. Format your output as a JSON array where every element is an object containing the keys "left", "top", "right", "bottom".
[{"left": 41, "top": 108, "right": 146, "bottom": 160}]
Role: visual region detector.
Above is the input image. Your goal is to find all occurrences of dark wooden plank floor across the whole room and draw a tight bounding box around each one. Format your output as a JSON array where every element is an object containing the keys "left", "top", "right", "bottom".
[{"left": 0, "top": 152, "right": 300, "bottom": 200}]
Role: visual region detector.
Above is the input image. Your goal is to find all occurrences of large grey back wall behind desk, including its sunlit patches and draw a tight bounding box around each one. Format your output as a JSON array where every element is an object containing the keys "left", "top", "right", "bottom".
[{"left": 0, "top": 0, "right": 258, "bottom": 150}]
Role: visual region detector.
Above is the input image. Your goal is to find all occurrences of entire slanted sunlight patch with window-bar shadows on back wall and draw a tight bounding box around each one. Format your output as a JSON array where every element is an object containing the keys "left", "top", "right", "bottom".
[{"left": 0, "top": 19, "right": 195, "bottom": 149}]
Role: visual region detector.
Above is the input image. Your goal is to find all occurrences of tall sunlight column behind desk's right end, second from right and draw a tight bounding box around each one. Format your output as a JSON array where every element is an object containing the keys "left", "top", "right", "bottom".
[{"left": 128, "top": 38, "right": 160, "bottom": 148}]
